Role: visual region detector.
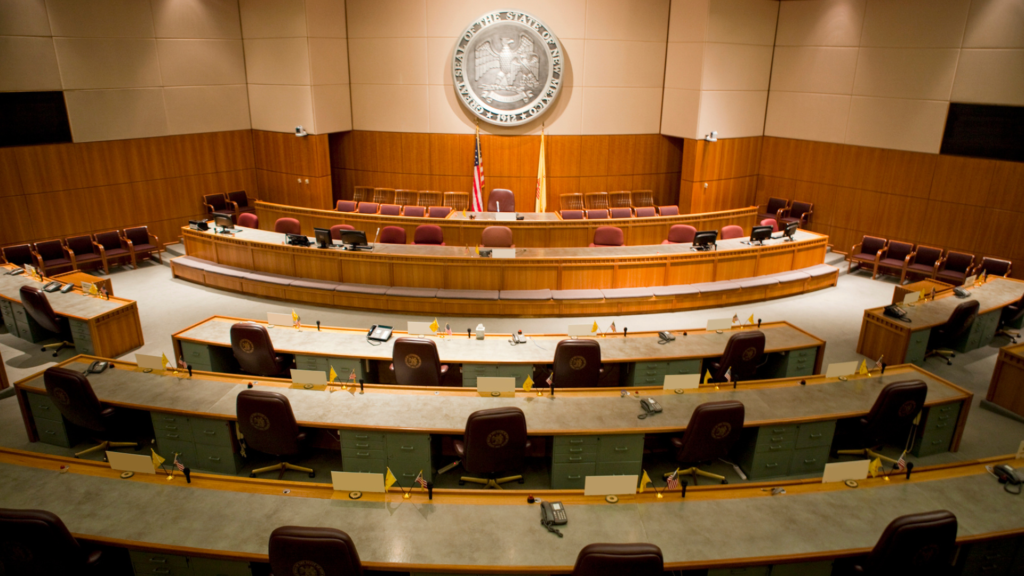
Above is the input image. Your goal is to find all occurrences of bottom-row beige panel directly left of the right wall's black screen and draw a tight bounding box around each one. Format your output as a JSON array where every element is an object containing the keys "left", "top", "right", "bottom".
[{"left": 846, "top": 96, "right": 949, "bottom": 154}]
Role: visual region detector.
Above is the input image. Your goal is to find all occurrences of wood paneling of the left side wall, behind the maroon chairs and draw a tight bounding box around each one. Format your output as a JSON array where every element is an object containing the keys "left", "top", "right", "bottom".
[{"left": 0, "top": 130, "right": 256, "bottom": 250}]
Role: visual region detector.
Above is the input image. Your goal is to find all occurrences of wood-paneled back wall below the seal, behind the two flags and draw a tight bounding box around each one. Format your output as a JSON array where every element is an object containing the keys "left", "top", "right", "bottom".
[{"left": 330, "top": 131, "right": 683, "bottom": 211}]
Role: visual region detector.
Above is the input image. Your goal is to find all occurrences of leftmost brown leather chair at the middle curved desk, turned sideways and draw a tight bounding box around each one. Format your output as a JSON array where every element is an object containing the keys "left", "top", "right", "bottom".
[{"left": 43, "top": 366, "right": 139, "bottom": 460}]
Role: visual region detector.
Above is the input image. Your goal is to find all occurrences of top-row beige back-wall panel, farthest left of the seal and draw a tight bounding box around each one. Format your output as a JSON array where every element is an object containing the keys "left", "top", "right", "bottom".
[{"left": 346, "top": 0, "right": 423, "bottom": 40}]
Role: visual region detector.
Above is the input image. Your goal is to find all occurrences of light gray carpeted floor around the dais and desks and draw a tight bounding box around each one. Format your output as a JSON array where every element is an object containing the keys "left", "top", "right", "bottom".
[{"left": 0, "top": 245, "right": 1024, "bottom": 482}]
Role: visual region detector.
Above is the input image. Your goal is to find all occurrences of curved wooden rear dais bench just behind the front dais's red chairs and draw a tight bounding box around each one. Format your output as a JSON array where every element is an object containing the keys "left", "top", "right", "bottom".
[{"left": 256, "top": 202, "right": 758, "bottom": 248}]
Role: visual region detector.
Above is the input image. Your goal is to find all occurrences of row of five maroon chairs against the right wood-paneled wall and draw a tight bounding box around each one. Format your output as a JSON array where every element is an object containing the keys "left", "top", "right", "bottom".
[{"left": 846, "top": 236, "right": 1013, "bottom": 286}]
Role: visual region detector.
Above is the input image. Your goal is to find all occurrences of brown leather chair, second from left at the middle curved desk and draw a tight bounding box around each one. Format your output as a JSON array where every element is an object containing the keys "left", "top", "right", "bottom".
[{"left": 234, "top": 389, "right": 316, "bottom": 478}]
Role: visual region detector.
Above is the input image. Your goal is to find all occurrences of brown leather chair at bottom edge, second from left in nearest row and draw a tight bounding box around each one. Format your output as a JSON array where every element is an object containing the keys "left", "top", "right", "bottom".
[{"left": 269, "top": 526, "right": 362, "bottom": 576}]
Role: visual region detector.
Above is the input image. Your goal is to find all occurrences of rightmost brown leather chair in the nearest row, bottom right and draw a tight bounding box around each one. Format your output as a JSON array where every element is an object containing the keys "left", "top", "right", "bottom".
[{"left": 853, "top": 510, "right": 957, "bottom": 576}]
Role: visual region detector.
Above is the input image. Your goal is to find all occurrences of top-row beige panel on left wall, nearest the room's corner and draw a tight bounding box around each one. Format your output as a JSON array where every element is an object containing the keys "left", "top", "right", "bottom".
[{"left": 152, "top": 0, "right": 242, "bottom": 39}]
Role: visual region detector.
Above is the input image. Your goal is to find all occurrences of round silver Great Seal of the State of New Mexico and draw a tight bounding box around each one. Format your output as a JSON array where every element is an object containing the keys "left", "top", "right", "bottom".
[{"left": 452, "top": 10, "right": 565, "bottom": 126}]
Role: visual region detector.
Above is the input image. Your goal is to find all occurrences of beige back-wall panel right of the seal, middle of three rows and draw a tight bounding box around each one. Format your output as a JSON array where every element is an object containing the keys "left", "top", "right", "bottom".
[{"left": 578, "top": 40, "right": 665, "bottom": 88}]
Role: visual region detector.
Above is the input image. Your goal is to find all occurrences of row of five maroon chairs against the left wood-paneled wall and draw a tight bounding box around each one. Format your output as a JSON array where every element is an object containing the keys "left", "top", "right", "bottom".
[{"left": 2, "top": 227, "right": 163, "bottom": 276}]
